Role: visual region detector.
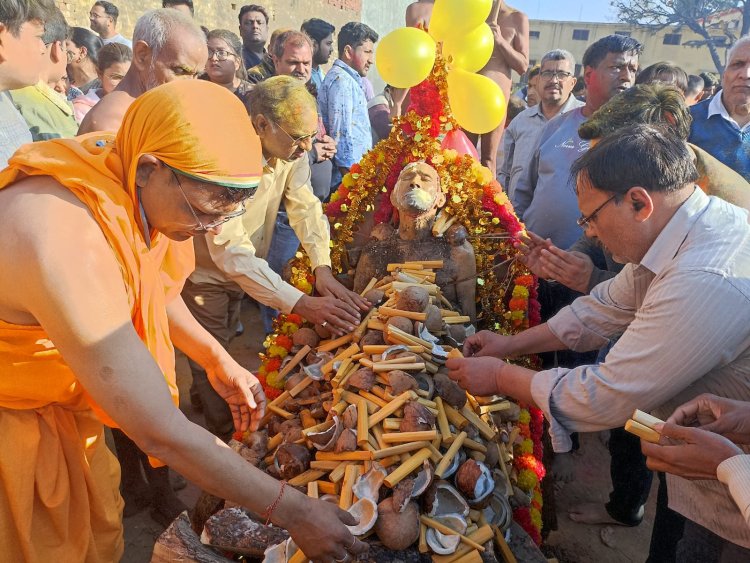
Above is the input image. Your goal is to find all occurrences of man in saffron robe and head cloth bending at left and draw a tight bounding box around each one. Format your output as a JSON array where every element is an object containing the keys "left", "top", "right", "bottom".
[{"left": 0, "top": 81, "right": 366, "bottom": 562}]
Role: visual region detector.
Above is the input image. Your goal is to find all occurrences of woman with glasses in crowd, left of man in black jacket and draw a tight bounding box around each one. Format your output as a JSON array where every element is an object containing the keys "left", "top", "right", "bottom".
[{"left": 206, "top": 29, "right": 252, "bottom": 99}]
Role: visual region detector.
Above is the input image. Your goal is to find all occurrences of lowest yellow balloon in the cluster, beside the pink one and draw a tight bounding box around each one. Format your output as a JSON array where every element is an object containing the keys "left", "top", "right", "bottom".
[{"left": 448, "top": 68, "right": 507, "bottom": 135}]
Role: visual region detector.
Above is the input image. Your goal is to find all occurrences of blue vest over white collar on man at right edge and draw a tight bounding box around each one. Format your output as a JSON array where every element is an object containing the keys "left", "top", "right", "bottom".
[{"left": 688, "top": 97, "right": 750, "bottom": 182}]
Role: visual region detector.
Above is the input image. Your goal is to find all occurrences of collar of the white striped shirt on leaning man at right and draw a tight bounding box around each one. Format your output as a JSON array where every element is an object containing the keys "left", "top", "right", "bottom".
[{"left": 640, "top": 186, "right": 709, "bottom": 275}]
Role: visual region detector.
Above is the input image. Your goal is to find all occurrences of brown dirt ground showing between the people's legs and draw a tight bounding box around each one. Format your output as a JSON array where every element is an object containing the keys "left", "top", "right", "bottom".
[{"left": 122, "top": 302, "right": 656, "bottom": 563}]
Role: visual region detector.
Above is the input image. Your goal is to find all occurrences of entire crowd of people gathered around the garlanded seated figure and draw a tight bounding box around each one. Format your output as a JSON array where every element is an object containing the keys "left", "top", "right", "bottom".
[{"left": 0, "top": 0, "right": 750, "bottom": 563}]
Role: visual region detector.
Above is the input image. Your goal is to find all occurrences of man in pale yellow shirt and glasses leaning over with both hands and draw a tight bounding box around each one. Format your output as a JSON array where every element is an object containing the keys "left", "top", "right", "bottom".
[{"left": 183, "top": 76, "right": 369, "bottom": 439}]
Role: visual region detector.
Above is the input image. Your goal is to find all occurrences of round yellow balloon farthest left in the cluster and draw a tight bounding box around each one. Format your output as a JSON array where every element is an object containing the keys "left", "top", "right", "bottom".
[{"left": 375, "top": 27, "right": 435, "bottom": 88}]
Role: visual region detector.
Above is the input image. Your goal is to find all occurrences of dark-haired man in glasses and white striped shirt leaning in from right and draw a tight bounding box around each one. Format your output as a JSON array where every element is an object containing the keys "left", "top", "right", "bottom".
[{"left": 448, "top": 125, "right": 750, "bottom": 561}]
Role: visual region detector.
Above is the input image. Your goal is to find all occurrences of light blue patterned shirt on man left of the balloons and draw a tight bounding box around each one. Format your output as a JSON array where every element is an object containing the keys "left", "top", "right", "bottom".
[{"left": 318, "top": 59, "right": 372, "bottom": 187}]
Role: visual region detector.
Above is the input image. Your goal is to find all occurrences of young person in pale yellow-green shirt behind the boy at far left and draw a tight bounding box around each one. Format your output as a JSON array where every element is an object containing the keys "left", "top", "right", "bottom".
[{"left": 10, "top": 7, "right": 78, "bottom": 141}]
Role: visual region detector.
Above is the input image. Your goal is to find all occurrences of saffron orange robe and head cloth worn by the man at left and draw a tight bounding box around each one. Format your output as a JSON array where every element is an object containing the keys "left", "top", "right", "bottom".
[{"left": 0, "top": 81, "right": 261, "bottom": 562}]
